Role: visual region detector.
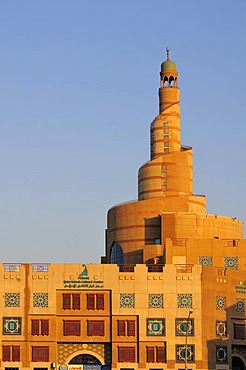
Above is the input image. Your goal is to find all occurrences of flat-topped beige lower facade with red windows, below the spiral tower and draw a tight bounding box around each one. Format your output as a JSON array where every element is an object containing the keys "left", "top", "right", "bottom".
[{"left": 1, "top": 257, "right": 246, "bottom": 370}]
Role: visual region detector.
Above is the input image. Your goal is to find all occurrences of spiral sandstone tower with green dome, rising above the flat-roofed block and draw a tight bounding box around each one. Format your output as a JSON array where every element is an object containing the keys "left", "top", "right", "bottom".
[{"left": 102, "top": 49, "right": 245, "bottom": 266}]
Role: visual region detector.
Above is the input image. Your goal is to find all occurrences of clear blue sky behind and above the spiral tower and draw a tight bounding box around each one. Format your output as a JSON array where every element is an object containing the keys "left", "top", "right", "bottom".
[{"left": 0, "top": 0, "right": 246, "bottom": 263}]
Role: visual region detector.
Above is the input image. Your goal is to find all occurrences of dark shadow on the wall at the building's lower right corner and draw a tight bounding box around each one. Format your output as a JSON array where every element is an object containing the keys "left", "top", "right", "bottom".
[{"left": 207, "top": 296, "right": 246, "bottom": 370}]
